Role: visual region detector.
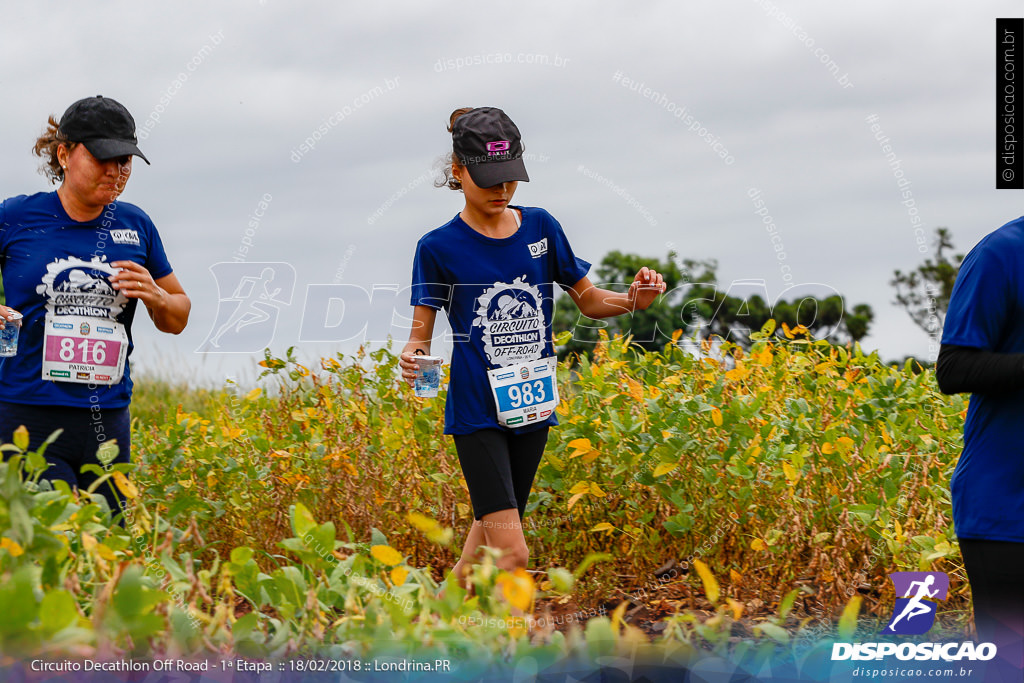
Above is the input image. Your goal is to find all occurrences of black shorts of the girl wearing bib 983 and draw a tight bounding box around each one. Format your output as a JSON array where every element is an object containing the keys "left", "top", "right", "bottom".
[{"left": 455, "top": 427, "right": 548, "bottom": 519}]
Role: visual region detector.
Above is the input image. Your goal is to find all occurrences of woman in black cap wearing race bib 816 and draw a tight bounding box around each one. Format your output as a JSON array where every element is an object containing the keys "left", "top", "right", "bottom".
[{"left": 0, "top": 95, "right": 191, "bottom": 523}]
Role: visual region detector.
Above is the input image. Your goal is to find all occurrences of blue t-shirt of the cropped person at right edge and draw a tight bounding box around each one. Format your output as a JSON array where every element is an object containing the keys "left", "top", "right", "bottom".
[{"left": 942, "top": 218, "right": 1024, "bottom": 543}]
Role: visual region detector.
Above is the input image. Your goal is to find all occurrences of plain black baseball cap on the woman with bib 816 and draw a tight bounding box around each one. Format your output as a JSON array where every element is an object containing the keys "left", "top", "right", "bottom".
[{"left": 57, "top": 95, "right": 150, "bottom": 164}]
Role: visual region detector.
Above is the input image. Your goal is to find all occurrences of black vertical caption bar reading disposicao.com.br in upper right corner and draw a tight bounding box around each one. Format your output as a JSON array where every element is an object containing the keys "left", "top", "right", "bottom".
[{"left": 995, "top": 18, "right": 1024, "bottom": 189}]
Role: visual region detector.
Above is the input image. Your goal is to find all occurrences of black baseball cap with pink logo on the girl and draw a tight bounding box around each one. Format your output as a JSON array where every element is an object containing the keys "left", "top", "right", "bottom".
[{"left": 452, "top": 106, "right": 529, "bottom": 187}]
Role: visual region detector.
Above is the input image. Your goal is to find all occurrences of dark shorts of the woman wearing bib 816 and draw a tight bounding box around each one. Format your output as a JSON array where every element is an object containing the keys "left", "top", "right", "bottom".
[{"left": 0, "top": 402, "right": 131, "bottom": 516}]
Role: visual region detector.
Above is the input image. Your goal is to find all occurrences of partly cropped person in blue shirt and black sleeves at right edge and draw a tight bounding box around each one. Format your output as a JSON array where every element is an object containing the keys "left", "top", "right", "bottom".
[{"left": 935, "top": 218, "right": 1024, "bottom": 681}]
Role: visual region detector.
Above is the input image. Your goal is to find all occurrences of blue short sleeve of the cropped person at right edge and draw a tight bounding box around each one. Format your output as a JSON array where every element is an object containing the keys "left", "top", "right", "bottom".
[{"left": 942, "top": 239, "right": 1015, "bottom": 351}]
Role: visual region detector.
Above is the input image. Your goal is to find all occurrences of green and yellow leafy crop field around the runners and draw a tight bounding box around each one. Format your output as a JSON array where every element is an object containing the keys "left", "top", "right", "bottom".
[{"left": 0, "top": 331, "right": 968, "bottom": 658}]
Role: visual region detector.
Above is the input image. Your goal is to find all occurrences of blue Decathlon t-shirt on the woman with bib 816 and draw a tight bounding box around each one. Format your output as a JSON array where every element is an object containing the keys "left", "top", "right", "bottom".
[{"left": 0, "top": 193, "right": 172, "bottom": 409}]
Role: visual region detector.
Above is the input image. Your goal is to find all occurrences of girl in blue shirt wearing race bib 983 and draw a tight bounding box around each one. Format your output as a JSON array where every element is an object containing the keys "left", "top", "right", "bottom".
[{"left": 399, "top": 108, "right": 665, "bottom": 587}]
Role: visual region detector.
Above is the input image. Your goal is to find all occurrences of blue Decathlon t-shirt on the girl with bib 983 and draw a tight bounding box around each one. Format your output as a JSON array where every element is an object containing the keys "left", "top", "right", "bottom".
[{"left": 412, "top": 207, "right": 590, "bottom": 434}]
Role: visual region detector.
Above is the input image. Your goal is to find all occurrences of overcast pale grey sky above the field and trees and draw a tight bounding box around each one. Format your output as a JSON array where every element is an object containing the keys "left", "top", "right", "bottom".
[{"left": 0, "top": 0, "right": 1022, "bottom": 379}]
